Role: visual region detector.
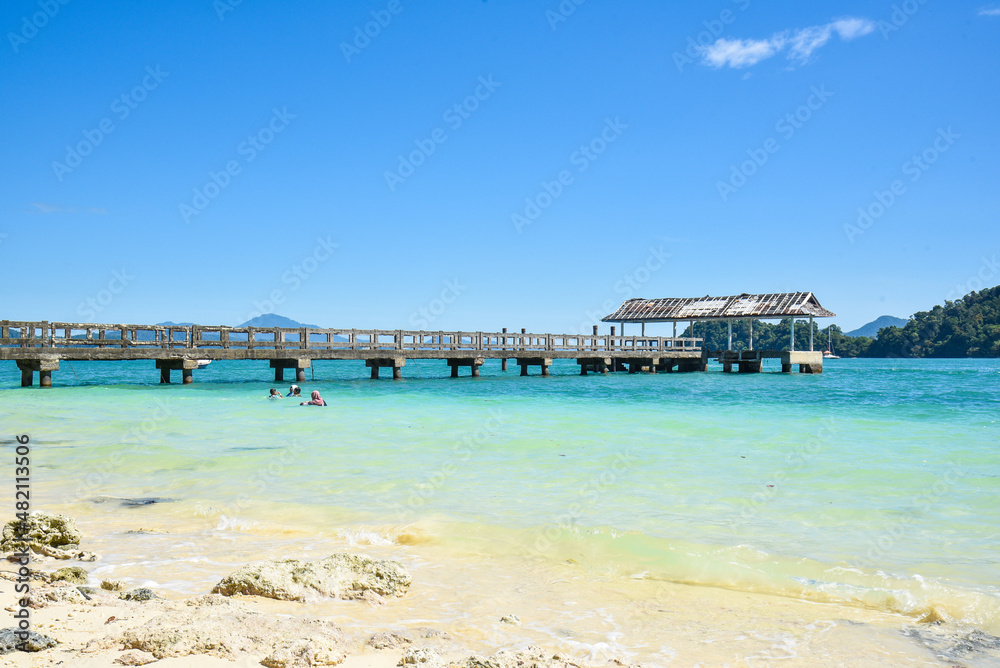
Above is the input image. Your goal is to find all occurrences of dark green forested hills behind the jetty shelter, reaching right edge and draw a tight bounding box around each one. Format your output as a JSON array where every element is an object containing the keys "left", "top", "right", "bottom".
[{"left": 683, "top": 286, "right": 1000, "bottom": 357}]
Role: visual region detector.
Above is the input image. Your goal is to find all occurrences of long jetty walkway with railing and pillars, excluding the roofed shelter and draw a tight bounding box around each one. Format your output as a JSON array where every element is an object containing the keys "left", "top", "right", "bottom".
[{"left": 0, "top": 320, "right": 720, "bottom": 387}]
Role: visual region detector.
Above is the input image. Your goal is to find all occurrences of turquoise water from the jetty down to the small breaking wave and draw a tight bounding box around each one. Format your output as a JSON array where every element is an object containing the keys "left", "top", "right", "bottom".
[{"left": 0, "top": 360, "right": 1000, "bottom": 633}]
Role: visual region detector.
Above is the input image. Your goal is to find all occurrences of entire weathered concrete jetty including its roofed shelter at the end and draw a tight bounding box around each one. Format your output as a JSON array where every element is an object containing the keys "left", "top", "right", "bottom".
[{"left": 0, "top": 293, "right": 833, "bottom": 387}]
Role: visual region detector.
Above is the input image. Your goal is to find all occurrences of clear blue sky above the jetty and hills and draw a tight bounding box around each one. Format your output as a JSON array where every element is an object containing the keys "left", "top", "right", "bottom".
[{"left": 0, "top": 0, "right": 1000, "bottom": 331}]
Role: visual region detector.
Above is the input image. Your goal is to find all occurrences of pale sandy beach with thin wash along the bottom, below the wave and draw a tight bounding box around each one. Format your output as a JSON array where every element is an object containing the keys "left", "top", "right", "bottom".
[{"left": 7, "top": 508, "right": 1000, "bottom": 668}]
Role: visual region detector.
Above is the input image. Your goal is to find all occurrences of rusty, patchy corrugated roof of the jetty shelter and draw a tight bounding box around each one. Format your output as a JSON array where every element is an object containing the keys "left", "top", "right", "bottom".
[{"left": 601, "top": 292, "right": 837, "bottom": 322}]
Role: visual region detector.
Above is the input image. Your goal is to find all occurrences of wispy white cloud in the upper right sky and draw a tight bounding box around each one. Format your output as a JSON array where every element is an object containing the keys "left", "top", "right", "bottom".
[{"left": 701, "top": 17, "right": 875, "bottom": 69}]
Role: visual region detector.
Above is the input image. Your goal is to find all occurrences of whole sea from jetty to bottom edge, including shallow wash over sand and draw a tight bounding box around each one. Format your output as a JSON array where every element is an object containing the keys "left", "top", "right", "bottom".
[{"left": 0, "top": 359, "right": 1000, "bottom": 666}]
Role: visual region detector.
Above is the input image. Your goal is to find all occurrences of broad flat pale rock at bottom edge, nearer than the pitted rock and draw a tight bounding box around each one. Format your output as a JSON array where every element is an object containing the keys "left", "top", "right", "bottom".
[{"left": 119, "top": 596, "right": 347, "bottom": 668}]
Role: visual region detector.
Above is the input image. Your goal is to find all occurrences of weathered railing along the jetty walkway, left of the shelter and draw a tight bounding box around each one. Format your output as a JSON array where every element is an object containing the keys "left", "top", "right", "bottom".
[{"left": 0, "top": 320, "right": 703, "bottom": 357}]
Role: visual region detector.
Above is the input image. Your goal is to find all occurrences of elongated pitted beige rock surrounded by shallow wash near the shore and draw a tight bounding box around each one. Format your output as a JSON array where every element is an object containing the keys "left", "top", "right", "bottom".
[{"left": 212, "top": 554, "right": 411, "bottom": 601}]
